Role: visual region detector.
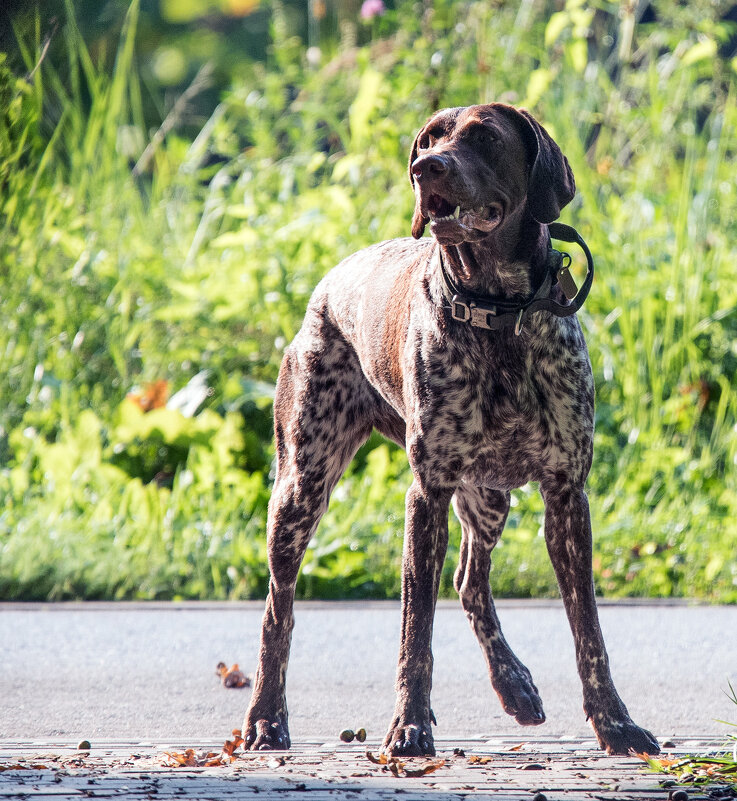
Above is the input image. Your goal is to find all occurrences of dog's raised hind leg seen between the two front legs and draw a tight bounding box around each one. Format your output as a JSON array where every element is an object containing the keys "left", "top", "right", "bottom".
[{"left": 453, "top": 484, "right": 545, "bottom": 726}]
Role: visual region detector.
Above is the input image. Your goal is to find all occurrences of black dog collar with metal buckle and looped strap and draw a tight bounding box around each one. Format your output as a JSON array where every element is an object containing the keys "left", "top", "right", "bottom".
[{"left": 438, "top": 223, "right": 594, "bottom": 334}]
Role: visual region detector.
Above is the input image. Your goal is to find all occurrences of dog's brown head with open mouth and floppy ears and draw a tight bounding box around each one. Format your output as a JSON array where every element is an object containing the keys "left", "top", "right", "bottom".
[{"left": 409, "top": 103, "right": 576, "bottom": 245}]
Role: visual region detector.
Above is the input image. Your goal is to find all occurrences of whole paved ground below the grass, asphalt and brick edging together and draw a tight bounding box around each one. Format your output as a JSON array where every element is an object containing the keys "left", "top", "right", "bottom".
[{"left": 0, "top": 602, "right": 737, "bottom": 801}]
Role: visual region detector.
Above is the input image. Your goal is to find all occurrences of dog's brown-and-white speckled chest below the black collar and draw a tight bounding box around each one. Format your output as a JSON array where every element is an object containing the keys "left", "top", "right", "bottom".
[{"left": 414, "top": 324, "right": 593, "bottom": 489}]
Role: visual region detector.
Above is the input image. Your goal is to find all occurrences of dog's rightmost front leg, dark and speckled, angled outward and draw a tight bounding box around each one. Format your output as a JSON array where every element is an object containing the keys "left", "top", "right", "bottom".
[{"left": 541, "top": 483, "right": 660, "bottom": 754}]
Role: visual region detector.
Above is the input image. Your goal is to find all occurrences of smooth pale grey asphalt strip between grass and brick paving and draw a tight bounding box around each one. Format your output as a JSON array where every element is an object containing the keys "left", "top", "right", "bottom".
[{"left": 0, "top": 601, "right": 737, "bottom": 744}]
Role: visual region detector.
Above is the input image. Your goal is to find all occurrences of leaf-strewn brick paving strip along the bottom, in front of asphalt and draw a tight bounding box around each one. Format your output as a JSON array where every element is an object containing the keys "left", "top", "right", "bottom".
[{"left": 0, "top": 738, "right": 735, "bottom": 801}]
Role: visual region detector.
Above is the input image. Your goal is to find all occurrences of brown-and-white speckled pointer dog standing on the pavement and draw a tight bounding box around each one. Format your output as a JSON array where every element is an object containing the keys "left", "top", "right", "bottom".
[{"left": 243, "top": 103, "right": 659, "bottom": 756}]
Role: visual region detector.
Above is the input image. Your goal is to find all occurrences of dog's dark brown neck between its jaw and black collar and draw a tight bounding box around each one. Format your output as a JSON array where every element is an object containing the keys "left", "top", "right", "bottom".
[{"left": 441, "top": 207, "right": 549, "bottom": 301}]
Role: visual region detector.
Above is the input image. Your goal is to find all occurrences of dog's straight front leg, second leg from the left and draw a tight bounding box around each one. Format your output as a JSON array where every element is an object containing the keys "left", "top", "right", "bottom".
[{"left": 383, "top": 480, "right": 453, "bottom": 756}]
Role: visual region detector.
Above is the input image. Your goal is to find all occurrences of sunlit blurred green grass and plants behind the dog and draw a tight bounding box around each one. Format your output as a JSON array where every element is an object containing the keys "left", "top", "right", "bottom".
[{"left": 0, "top": 0, "right": 737, "bottom": 602}]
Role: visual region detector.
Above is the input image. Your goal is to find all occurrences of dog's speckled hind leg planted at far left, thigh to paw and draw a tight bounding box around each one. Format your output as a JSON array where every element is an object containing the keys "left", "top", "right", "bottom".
[{"left": 243, "top": 328, "right": 371, "bottom": 750}]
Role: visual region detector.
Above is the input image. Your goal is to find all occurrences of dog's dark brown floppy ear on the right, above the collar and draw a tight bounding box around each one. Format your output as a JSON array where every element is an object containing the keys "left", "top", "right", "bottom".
[{"left": 515, "top": 109, "right": 576, "bottom": 224}]
